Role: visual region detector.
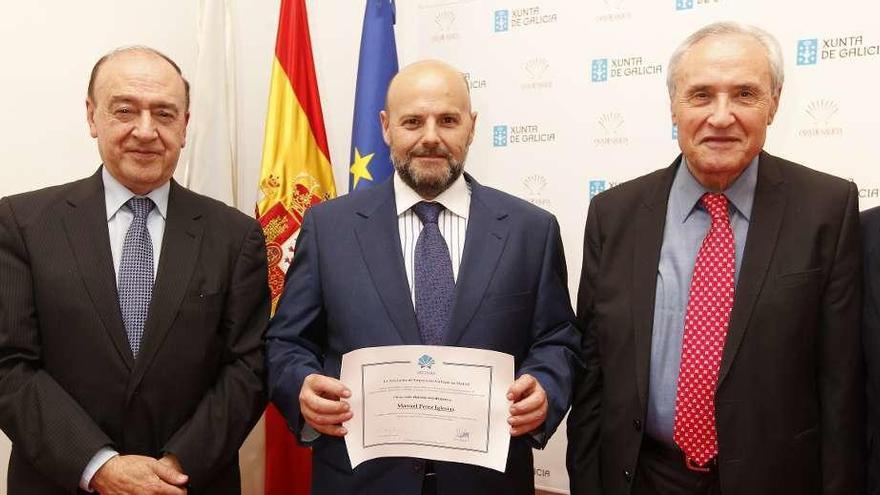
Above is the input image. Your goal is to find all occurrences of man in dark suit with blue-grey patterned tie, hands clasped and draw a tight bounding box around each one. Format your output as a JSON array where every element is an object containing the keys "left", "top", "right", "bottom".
[{"left": 0, "top": 47, "right": 269, "bottom": 495}]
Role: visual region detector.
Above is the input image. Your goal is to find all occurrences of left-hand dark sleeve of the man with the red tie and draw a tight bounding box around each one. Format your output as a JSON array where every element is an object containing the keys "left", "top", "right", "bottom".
[{"left": 566, "top": 200, "right": 602, "bottom": 495}]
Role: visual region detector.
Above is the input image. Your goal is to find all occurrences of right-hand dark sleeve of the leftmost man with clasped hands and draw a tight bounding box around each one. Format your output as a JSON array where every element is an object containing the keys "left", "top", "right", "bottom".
[{"left": 163, "top": 222, "right": 269, "bottom": 490}]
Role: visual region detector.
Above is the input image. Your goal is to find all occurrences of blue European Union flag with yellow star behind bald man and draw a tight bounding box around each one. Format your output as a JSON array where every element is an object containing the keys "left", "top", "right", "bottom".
[{"left": 348, "top": 0, "right": 397, "bottom": 191}]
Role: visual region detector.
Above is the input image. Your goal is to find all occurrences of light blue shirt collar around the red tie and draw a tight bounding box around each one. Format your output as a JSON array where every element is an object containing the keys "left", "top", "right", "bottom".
[{"left": 672, "top": 155, "right": 758, "bottom": 223}]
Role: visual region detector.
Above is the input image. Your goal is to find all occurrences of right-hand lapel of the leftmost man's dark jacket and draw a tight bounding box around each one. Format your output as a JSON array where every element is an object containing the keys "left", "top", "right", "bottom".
[{"left": 129, "top": 181, "right": 203, "bottom": 391}]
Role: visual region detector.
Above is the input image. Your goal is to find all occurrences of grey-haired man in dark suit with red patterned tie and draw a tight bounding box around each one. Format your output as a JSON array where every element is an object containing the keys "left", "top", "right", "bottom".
[{"left": 568, "top": 23, "right": 863, "bottom": 495}]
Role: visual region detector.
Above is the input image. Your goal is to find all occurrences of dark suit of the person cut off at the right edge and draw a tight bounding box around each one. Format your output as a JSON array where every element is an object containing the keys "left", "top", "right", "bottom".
[{"left": 861, "top": 207, "right": 880, "bottom": 495}]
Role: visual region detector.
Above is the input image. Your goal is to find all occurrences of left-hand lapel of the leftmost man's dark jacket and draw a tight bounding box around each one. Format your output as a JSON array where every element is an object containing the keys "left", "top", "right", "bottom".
[{"left": 64, "top": 169, "right": 134, "bottom": 369}]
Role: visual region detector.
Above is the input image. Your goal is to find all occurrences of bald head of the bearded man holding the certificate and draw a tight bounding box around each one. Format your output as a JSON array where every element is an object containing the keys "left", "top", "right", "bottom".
[{"left": 379, "top": 60, "right": 477, "bottom": 199}]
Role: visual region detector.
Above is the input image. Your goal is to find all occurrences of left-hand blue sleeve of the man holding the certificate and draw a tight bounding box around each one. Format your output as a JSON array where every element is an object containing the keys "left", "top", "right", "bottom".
[{"left": 266, "top": 210, "right": 326, "bottom": 442}]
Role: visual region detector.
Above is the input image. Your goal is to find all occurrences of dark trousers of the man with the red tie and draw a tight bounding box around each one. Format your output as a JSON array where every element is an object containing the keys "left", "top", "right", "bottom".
[{"left": 632, "top": 436, "right": 721, "bottom": 495}]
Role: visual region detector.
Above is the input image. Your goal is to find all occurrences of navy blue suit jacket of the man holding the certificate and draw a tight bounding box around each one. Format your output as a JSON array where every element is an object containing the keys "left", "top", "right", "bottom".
[{"left": 267, "top": 177, "right": 581, "bottom": 495}]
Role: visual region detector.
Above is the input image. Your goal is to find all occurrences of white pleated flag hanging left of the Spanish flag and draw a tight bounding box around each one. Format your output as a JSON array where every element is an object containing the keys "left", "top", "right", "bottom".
[{"left": 175, "top": 0, "right": 238, "bottom": 206}]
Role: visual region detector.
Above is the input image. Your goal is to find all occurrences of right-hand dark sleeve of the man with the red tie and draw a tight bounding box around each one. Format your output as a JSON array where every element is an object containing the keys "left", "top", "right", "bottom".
[{"left": 818, "top": 183, "right": 864, "bottom": 495}]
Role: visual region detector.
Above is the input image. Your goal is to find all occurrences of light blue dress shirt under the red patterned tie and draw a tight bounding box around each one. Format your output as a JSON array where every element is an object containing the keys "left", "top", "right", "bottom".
[{"left": 645, "top": 156, "right": 758, "bottom": 446}]
